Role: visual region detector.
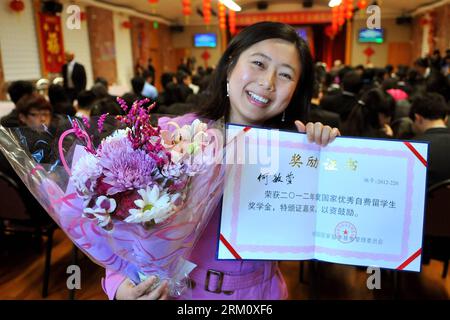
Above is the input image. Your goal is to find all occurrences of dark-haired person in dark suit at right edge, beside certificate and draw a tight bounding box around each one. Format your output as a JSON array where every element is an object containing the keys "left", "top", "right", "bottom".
[{"left": 409, "top": 93, "right": 450, "bottom": 187}]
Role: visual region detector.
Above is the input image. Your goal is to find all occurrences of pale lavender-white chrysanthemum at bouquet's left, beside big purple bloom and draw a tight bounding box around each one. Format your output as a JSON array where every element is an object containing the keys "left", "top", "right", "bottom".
[{"left": 70, "top": 153, "right": 102, "bottom": 195}]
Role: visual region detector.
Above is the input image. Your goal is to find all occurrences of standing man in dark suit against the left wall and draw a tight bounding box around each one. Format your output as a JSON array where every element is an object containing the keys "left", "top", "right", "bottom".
[{"left": 62, "top": 52, "right": 86, "bottom": 102}]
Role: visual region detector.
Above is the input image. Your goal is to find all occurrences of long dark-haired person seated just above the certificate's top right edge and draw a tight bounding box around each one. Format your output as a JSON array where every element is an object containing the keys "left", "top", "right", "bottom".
[{"left": 342, "top": 89, "right": 395, "bottom": 138}]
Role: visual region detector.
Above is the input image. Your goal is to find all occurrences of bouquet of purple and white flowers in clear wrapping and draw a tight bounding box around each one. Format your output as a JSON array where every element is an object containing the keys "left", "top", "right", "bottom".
[{"left": 0, "top": 99, "right": 224, "bottom": 297}]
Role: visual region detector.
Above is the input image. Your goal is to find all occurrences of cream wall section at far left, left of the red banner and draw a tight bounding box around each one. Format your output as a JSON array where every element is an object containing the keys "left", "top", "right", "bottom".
[{"left": 0, "top": 0, "right": 41, "bottom": 81}]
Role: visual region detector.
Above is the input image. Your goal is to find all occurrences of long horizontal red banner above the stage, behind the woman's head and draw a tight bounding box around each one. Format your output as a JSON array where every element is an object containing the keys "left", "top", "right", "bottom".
[{"left": 236, "top": 11, "right": 331, "bottom": 26}]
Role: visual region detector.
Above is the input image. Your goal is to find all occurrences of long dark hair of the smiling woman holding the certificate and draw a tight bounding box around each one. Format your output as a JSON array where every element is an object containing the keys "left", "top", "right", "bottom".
[{"left": 200, "top": 22, "right": 314, "bottom": 128}]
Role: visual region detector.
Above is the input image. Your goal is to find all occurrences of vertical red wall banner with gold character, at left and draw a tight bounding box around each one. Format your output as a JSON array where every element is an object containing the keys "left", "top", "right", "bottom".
[{"left": 39, "top": 13, "right": 64, "bottom": 73}]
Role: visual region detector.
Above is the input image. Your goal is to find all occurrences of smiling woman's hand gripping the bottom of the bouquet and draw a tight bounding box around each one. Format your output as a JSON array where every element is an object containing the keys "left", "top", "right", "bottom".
[{"left": 115, "top": 276, "right": 169, "bottom": 300}]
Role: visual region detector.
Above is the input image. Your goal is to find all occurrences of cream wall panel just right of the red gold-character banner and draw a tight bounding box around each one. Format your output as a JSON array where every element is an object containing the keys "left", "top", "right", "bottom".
[{"left": 61, "top": 0, "right": 94, "bottom": 89}]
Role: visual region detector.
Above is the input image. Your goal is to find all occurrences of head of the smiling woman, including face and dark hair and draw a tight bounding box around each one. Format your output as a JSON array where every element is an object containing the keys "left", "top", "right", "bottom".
[{"left": 202, "top": 22, "right": 314, "bottom": 129}]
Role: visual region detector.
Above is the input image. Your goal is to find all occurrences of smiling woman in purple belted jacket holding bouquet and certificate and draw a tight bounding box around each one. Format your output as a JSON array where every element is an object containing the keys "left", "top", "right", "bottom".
[{"left": 104, "top": 22, "right": 339, "bottom": 300}]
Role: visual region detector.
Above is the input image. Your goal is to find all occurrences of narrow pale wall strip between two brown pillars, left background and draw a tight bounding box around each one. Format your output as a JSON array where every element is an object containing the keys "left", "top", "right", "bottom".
[{"left": 113, "top": 12, "right": 133, "bottom": 91}]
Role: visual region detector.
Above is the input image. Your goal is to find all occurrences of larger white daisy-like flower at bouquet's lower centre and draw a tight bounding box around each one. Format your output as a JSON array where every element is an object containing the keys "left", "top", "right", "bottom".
[{"left": 125, "top": 186, "right": 173, "bottom": 223}]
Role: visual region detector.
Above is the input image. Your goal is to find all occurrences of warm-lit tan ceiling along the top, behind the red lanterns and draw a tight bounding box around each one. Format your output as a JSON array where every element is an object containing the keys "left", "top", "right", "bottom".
[{"left": 95, "top": 0, "right": 439, "bottom": 24}]
